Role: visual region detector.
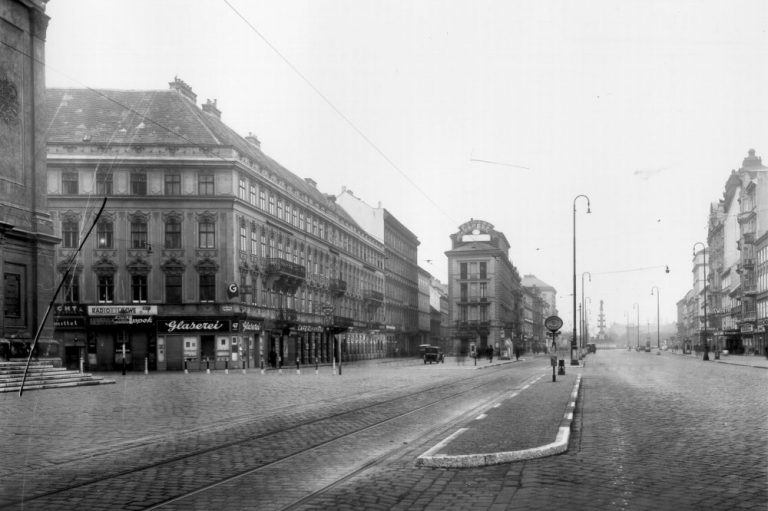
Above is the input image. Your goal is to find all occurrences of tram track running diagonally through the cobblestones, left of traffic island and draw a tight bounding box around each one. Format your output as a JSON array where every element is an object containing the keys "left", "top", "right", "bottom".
[{"left": 0, "top": 369, "right": 536, "bottom": 510}]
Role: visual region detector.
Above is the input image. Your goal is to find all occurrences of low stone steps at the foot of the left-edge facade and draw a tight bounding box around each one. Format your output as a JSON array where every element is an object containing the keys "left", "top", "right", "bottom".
[{"left": 0, "top": 362, "right": 115, "bottom": 393}]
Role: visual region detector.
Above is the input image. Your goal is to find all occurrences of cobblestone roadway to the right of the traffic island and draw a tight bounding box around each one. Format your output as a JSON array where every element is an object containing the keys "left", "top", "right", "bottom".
[{"left": 296, "top": 350, "right": 768, "bottom": 510}]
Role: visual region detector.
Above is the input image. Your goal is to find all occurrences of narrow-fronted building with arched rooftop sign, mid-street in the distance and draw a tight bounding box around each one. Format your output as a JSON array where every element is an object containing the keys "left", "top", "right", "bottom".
[{"left": 445, "top": 219, "right": 523, "bottom": 354}]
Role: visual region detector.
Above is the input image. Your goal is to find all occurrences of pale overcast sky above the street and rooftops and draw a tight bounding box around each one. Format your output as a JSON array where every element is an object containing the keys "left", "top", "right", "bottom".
[{"left": 46, "top": 0, "right": 768, "bottom": 333}]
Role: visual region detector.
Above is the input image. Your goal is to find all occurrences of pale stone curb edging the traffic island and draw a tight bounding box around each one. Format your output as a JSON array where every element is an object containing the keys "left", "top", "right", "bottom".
[{"left": 416, "top": 374, "right": 581, "bottom": 468}]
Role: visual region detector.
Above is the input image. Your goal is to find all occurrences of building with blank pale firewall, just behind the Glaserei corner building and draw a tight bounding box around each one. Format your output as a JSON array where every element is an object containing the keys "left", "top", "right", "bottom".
[{"left": 336, "top": 187, "right": 420, "bottom": 356}]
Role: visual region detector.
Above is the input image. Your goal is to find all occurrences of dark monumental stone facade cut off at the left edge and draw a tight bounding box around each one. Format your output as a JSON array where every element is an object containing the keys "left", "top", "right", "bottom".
[{"left": 0, "top": 0, "right": 58, "bottom": 360}]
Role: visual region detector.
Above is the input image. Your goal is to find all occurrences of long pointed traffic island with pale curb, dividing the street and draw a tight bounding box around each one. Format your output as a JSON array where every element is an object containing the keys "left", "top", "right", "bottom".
[{"left": 416, "top": 366, "right": 583, "bottom": 468}]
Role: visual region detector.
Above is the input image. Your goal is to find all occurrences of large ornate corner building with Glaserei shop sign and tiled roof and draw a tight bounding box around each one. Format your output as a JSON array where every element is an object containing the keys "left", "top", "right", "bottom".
[{"left": 47, "top": 79, "right": 388, "bottom": 370}]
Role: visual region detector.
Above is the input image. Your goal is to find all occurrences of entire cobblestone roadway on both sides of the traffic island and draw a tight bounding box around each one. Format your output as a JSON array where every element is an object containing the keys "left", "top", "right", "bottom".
[{"left": 0, "top": 350, "right": 768, "bottom": 510}]
